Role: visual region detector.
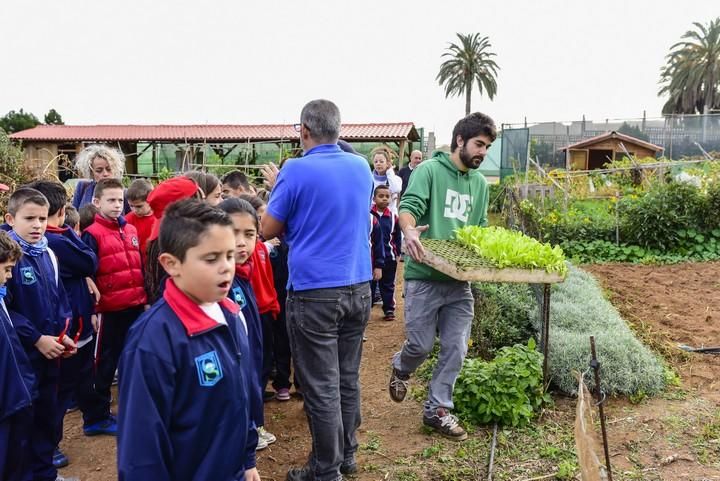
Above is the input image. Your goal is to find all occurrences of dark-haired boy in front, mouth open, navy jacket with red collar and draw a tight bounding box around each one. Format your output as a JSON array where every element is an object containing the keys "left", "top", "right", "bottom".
[{"left": 118, "top": 199, "right": 260, "bottom": 481}]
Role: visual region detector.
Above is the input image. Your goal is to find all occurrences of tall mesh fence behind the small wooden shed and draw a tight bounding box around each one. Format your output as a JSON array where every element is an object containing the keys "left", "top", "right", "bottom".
[{"left": 502, "top": 114, "right": 720, "bottom": 168}]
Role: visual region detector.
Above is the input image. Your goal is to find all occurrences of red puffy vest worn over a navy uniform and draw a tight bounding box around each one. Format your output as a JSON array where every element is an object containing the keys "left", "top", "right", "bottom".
[{"left": 83, "top": 214, "right": 147, "bottom": 312}]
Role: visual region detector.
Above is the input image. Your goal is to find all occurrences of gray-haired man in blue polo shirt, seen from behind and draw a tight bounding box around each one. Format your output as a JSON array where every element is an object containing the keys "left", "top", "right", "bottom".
[{"left": 262, "top": 100, "right": 373, "bottom": 481}]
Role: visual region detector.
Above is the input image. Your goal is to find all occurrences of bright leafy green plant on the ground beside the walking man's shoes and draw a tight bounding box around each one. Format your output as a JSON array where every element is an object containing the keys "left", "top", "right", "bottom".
[{"left": 453, "top": 339, "right": 546, "bottom": 426}]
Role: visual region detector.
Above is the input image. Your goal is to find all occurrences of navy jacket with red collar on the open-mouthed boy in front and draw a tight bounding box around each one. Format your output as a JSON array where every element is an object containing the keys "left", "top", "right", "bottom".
[{"left": 117, "top": 280, "right": 258, "bottom": 481}]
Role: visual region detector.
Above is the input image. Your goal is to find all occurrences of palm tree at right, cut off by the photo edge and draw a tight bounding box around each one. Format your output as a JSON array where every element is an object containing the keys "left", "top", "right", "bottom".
[{"left": 658, "top": 17, "right": 720, "bottom": 114}]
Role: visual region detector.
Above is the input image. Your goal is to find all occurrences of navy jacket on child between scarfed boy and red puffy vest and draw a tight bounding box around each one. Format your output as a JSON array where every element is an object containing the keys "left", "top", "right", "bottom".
[{"left": 45, "top": 226, "right": 97, "bottom": 339}]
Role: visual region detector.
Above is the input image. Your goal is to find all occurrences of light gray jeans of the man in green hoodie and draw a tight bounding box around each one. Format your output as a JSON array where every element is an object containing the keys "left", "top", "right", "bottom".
[{"left": 393, "top": 280, "right": 475, "bottom": 415}]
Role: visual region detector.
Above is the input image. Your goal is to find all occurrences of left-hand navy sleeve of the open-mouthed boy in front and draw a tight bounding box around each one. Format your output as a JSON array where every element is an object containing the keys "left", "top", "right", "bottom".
[{"left": 117, "top": 349, "right": 176, "bottom": 481}]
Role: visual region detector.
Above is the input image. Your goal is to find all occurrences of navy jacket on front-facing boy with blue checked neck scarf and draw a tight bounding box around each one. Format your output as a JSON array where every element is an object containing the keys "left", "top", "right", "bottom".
[{"left": 5, "top": 240, "right": 72, "bottom": 361}]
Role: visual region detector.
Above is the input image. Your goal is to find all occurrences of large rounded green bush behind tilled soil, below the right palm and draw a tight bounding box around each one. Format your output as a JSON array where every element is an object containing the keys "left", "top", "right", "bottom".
[{"left": 618, "top": 182, "right": 704, "bottom": 251}]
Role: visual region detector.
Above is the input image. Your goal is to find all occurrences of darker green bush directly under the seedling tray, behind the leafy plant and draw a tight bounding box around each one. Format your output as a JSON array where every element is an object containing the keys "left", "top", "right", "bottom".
[{"left": 468, "top": 283, "right": 534, "bottom": 359}]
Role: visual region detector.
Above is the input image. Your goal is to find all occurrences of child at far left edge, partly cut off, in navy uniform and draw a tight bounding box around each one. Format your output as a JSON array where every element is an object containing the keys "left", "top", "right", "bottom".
[{"left": 0, "top": 231, "right": 37, "bottom": 481}]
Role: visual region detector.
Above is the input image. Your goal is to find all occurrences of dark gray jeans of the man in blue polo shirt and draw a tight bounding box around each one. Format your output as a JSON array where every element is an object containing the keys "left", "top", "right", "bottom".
[{"left": 287, "top": 282, "right": 372, "bottom": 481}]
